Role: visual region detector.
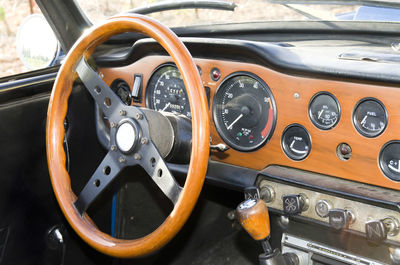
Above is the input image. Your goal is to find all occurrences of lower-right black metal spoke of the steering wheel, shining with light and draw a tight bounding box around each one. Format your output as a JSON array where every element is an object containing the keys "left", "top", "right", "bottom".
[{"left": 140, "top": 142, "right": 182, "bottom": 205}]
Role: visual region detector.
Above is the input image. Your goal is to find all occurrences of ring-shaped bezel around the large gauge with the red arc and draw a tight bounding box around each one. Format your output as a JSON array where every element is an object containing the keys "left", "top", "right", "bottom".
[{"left": 212, "top": 71, "right": 277, "bottom": 152}]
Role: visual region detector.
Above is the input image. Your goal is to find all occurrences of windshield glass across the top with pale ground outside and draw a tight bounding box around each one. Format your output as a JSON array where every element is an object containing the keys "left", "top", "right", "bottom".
[{"left": 78, "top": 0, "right": 400, "bottom": 27}]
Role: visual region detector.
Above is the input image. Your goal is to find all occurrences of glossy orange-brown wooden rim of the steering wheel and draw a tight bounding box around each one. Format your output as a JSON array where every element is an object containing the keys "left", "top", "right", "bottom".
[{"left": 46, "top": 15, "right": 210, "bottom": 258}]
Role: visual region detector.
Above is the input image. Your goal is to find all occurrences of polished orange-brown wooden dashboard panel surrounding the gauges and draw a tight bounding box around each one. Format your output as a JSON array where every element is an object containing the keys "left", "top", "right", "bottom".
[{"left": 99, "top": 56, "right": 400, "bottom": 190}]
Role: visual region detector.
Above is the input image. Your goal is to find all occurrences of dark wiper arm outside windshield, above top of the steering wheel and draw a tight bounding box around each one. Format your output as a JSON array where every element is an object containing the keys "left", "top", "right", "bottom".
[{"left": 127, "top": 0, "right": 236, "bottom": 15}]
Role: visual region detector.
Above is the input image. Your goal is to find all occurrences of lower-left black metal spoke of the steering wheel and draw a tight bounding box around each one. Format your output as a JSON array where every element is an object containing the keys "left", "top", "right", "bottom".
[{"left": 74, "top": 151, "right": 126, "bottom": 215}]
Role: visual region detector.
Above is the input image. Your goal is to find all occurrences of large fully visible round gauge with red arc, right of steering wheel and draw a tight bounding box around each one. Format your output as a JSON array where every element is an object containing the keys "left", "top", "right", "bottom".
[{"left": 213, "top": 72, "right": 276, "bottom": 151}]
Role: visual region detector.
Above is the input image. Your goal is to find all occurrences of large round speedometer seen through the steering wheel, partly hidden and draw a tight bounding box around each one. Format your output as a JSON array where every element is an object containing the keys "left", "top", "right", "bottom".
[{"left": 146, "top": 64, "right": 191, "bottom": 118}]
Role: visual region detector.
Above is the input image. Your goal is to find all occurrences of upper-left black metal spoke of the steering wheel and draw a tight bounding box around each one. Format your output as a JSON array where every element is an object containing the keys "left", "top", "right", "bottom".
[{"left": 75, "top": 57, "right": 124, "bottom": 119}]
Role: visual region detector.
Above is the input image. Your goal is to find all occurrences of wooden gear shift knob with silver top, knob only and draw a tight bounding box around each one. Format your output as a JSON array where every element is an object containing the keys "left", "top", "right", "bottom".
[{"left": 236, "top": 199, "right": 271, "bottom": 241}]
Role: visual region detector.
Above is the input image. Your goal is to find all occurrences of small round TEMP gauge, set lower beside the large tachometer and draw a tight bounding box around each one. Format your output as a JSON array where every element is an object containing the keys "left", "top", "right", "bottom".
[{"left": 282, "top": 124, "right": 311, "bottom": 160}]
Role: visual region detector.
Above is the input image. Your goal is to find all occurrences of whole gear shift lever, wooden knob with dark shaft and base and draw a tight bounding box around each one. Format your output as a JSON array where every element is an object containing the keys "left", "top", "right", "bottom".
[{"left": 236, "top": 199, "right": 299, "bottom": 265}]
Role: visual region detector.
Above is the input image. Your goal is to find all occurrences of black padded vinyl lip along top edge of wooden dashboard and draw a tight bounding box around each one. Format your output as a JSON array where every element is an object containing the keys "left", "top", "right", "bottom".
[{"left": 96, "top": 38, "right": 400, "bottom": 84}]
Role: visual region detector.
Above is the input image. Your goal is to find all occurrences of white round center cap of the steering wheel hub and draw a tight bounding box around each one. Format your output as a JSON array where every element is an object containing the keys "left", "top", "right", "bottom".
[{"left": 115, "top": 121, "right": 138, "bottom": 153}]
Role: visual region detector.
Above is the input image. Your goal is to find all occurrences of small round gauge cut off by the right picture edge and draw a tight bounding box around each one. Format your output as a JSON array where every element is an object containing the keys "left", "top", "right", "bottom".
[{"left": 379, "top": 141, "right": 400, "bottom": 181}]
